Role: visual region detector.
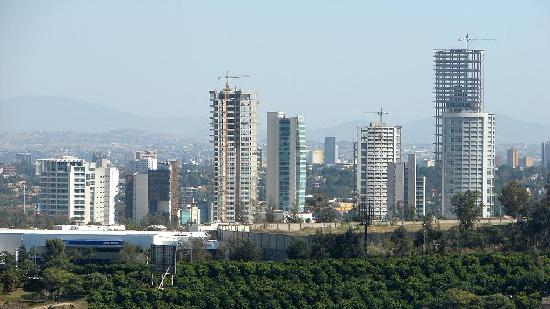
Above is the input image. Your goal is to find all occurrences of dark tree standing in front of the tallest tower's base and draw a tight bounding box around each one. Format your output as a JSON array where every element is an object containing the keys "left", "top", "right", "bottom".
[{"left": 451, "top": 190, "right": 482, "bottom": 231}]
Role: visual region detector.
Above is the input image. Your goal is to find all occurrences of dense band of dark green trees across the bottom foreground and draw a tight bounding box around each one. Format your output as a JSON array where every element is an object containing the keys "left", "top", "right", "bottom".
[{"left": 86, "top": 252, "right": 550, "bottom": 308}]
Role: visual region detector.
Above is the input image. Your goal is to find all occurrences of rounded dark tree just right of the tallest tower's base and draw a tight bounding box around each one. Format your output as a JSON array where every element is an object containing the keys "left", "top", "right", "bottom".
[{"left": 498, "top": 180, "right": 531, "bottom": 220}]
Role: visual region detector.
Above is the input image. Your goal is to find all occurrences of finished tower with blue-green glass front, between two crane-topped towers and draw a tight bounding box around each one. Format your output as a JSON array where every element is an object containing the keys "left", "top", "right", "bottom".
[{"left": 266, "top": 112, "right": 306, "bottom": 211}]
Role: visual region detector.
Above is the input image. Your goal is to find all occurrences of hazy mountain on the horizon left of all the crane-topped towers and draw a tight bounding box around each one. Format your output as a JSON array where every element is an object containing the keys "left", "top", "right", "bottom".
[{"left": 0, "top": 96, "right": 209, "bottom": 139}]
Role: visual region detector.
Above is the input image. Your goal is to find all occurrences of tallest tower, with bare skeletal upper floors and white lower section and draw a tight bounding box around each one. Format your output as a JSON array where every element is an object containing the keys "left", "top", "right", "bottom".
[{"left": 434, "top": 49, "right": 495, "bottom": 217}]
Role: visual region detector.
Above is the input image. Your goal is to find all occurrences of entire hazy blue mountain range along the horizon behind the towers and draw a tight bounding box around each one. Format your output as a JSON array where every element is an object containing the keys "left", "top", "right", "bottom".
[{"left": 0, "top": 96, "right": 550, "bottom": 144}]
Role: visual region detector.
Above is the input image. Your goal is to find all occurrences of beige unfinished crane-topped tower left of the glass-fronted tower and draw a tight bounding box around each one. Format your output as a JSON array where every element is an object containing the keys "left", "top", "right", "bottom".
[{"left": 209, "top": 84, "right": 258, "bottom": 222}]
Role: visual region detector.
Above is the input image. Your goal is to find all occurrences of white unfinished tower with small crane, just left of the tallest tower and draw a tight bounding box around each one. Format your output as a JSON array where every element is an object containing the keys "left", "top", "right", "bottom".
[{"left": 355, "top": 122, "right": 401, "bottom": 220}]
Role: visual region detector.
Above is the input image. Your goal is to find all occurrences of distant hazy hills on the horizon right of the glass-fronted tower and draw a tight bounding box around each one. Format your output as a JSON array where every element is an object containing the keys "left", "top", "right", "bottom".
[{"left": 306, "top": 115, "right": 550, "bottom": 144}]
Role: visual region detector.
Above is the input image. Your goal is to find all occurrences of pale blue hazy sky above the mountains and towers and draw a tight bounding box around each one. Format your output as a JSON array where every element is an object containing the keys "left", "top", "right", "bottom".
[{"left": 0, "top": 0, "right": 550, "bottom": 128}]
